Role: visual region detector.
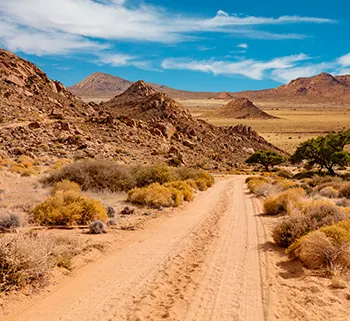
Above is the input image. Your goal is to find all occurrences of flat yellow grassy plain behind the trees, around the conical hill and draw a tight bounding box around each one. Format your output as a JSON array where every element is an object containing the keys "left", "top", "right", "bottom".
[{"left": 180, "top": 100, "right": 350, "bottom": 153}]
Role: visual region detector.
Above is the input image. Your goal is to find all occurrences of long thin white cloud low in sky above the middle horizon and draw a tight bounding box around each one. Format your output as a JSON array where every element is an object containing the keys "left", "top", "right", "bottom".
[{"left": 162, "top": 54, "right": 308, "bottom": 80}]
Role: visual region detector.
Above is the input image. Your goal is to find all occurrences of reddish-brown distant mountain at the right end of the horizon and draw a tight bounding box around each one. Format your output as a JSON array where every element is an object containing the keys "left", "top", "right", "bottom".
[{"left": 235, "top": 73, "right": 350, "bottom": 104}]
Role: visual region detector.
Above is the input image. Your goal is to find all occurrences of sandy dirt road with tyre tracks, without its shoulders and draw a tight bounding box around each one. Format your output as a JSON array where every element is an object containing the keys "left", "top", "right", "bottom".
[{"left": 1, "top": 177, "right": 266, "bottom": 321}]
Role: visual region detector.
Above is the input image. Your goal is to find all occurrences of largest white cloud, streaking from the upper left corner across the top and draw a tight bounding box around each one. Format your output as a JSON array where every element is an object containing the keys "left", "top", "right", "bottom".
[{"left": 0, "top": 0, "right": 334, "bottom": 54}]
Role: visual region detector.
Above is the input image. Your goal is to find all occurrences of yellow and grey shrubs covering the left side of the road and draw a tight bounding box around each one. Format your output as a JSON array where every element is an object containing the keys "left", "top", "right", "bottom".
[{"left": 0, "top": 157, "right": 214, "bottom": 294}]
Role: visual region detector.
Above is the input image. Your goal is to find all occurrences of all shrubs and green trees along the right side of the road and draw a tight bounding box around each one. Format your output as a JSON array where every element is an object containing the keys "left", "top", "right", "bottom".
[{"left": 246, "top": 130, "right": 350, "bottom": 286}]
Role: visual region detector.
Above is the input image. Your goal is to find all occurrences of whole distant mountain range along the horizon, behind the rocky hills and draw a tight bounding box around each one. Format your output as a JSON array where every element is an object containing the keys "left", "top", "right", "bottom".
[{"left": 68, "top": 72, "right": 350, "bottom": 104}]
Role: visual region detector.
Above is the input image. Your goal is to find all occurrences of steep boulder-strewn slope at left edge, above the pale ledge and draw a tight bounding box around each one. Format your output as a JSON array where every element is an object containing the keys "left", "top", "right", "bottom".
[{"left": 0, "top": 50, "right": 87, "bottom": 123}]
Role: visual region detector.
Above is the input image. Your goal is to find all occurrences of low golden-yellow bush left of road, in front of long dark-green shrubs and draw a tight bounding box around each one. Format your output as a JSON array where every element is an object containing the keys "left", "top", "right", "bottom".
[{"left": 128, "top": 183, "right": 184, "bottom": 207}]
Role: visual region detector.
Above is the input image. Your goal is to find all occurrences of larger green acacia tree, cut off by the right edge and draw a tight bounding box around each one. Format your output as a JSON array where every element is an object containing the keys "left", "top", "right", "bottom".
[{"left": 291, "top": 129, "right": 350, "bottom": 175}]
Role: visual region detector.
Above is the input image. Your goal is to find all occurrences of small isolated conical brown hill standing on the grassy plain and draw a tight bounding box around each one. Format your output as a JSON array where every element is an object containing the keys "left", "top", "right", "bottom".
[{"left": 209, "top": 98, "right": 276, "bottom": 119}]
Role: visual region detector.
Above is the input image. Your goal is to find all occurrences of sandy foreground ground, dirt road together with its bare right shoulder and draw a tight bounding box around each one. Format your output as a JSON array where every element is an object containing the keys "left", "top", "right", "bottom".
[{"left": 0, "top": 176, "right": 350, "bottom": 321}]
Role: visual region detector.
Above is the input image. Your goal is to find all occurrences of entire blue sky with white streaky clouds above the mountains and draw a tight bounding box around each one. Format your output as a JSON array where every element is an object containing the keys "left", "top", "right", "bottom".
[{"left": 0, "top": 0, "right": 350, "bottom": 91}]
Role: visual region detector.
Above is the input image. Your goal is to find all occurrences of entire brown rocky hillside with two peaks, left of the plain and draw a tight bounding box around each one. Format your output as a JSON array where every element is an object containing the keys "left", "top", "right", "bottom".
[{"left": 0, "top": 50, "right": 284, "bottom": 170}]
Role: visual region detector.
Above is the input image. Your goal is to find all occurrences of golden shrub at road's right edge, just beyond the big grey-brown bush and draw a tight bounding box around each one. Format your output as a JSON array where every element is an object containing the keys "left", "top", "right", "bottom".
[{"left": 264, "top": 188, "right": 306, "bottom": 215}]
